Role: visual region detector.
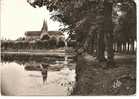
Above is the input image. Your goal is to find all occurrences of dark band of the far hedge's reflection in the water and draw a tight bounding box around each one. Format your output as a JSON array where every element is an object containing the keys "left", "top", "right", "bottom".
[{"left": 1, "top": 53, "right": 65, "bottom": 64}]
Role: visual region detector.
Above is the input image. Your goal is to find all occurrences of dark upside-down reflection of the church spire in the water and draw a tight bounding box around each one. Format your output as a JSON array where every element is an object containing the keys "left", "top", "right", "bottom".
[{"left": 40, "top": 64, "right": 49, "bottom": 84}]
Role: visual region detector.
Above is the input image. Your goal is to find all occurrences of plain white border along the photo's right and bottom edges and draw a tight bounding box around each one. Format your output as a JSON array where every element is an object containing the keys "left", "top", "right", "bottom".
[{"left": 0, "top": 0, "right": 139, "bottom": 99}]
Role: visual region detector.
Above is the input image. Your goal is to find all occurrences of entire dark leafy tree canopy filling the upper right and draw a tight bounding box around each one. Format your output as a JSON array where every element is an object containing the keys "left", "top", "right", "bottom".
[{"left": 27, "top": 0, "right": 136, "bottom": 61}]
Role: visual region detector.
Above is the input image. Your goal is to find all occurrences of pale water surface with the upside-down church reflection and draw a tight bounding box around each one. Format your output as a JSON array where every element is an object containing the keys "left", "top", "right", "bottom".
[{"left": 1, "top": 53, "right": 75, "bottom": 95}]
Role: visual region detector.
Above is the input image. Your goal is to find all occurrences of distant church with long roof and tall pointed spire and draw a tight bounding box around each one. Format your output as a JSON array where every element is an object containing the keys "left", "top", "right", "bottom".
[{"left": 25, "top": 20, "right": 64, "bottom": 41}]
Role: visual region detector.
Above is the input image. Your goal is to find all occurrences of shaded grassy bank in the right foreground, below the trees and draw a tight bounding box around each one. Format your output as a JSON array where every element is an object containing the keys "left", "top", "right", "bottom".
[{"left": 72, "top": 54, "right": 136, "bottom": 95}]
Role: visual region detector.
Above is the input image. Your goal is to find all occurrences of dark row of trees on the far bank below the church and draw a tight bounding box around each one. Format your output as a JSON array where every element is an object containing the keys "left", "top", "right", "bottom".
[{"left": 1, "top": 38, "right": 65, "bottom": 50}]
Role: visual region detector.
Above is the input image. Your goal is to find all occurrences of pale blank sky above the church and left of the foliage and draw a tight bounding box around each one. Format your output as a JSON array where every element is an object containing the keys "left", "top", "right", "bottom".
[{"left": 0, "top": 0, "right": 60, "bottom": 40}]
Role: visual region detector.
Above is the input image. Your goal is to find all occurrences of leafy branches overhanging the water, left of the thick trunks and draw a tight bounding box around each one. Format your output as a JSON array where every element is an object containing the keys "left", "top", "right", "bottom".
[{"left": 28, "top": 0, "right": 135, "bottom": 40}]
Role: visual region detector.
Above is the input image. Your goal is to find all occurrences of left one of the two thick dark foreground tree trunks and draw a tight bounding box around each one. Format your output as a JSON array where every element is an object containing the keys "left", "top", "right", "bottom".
[{"left": 96, "top": 0, "right": 105, "bottom": 62}]
